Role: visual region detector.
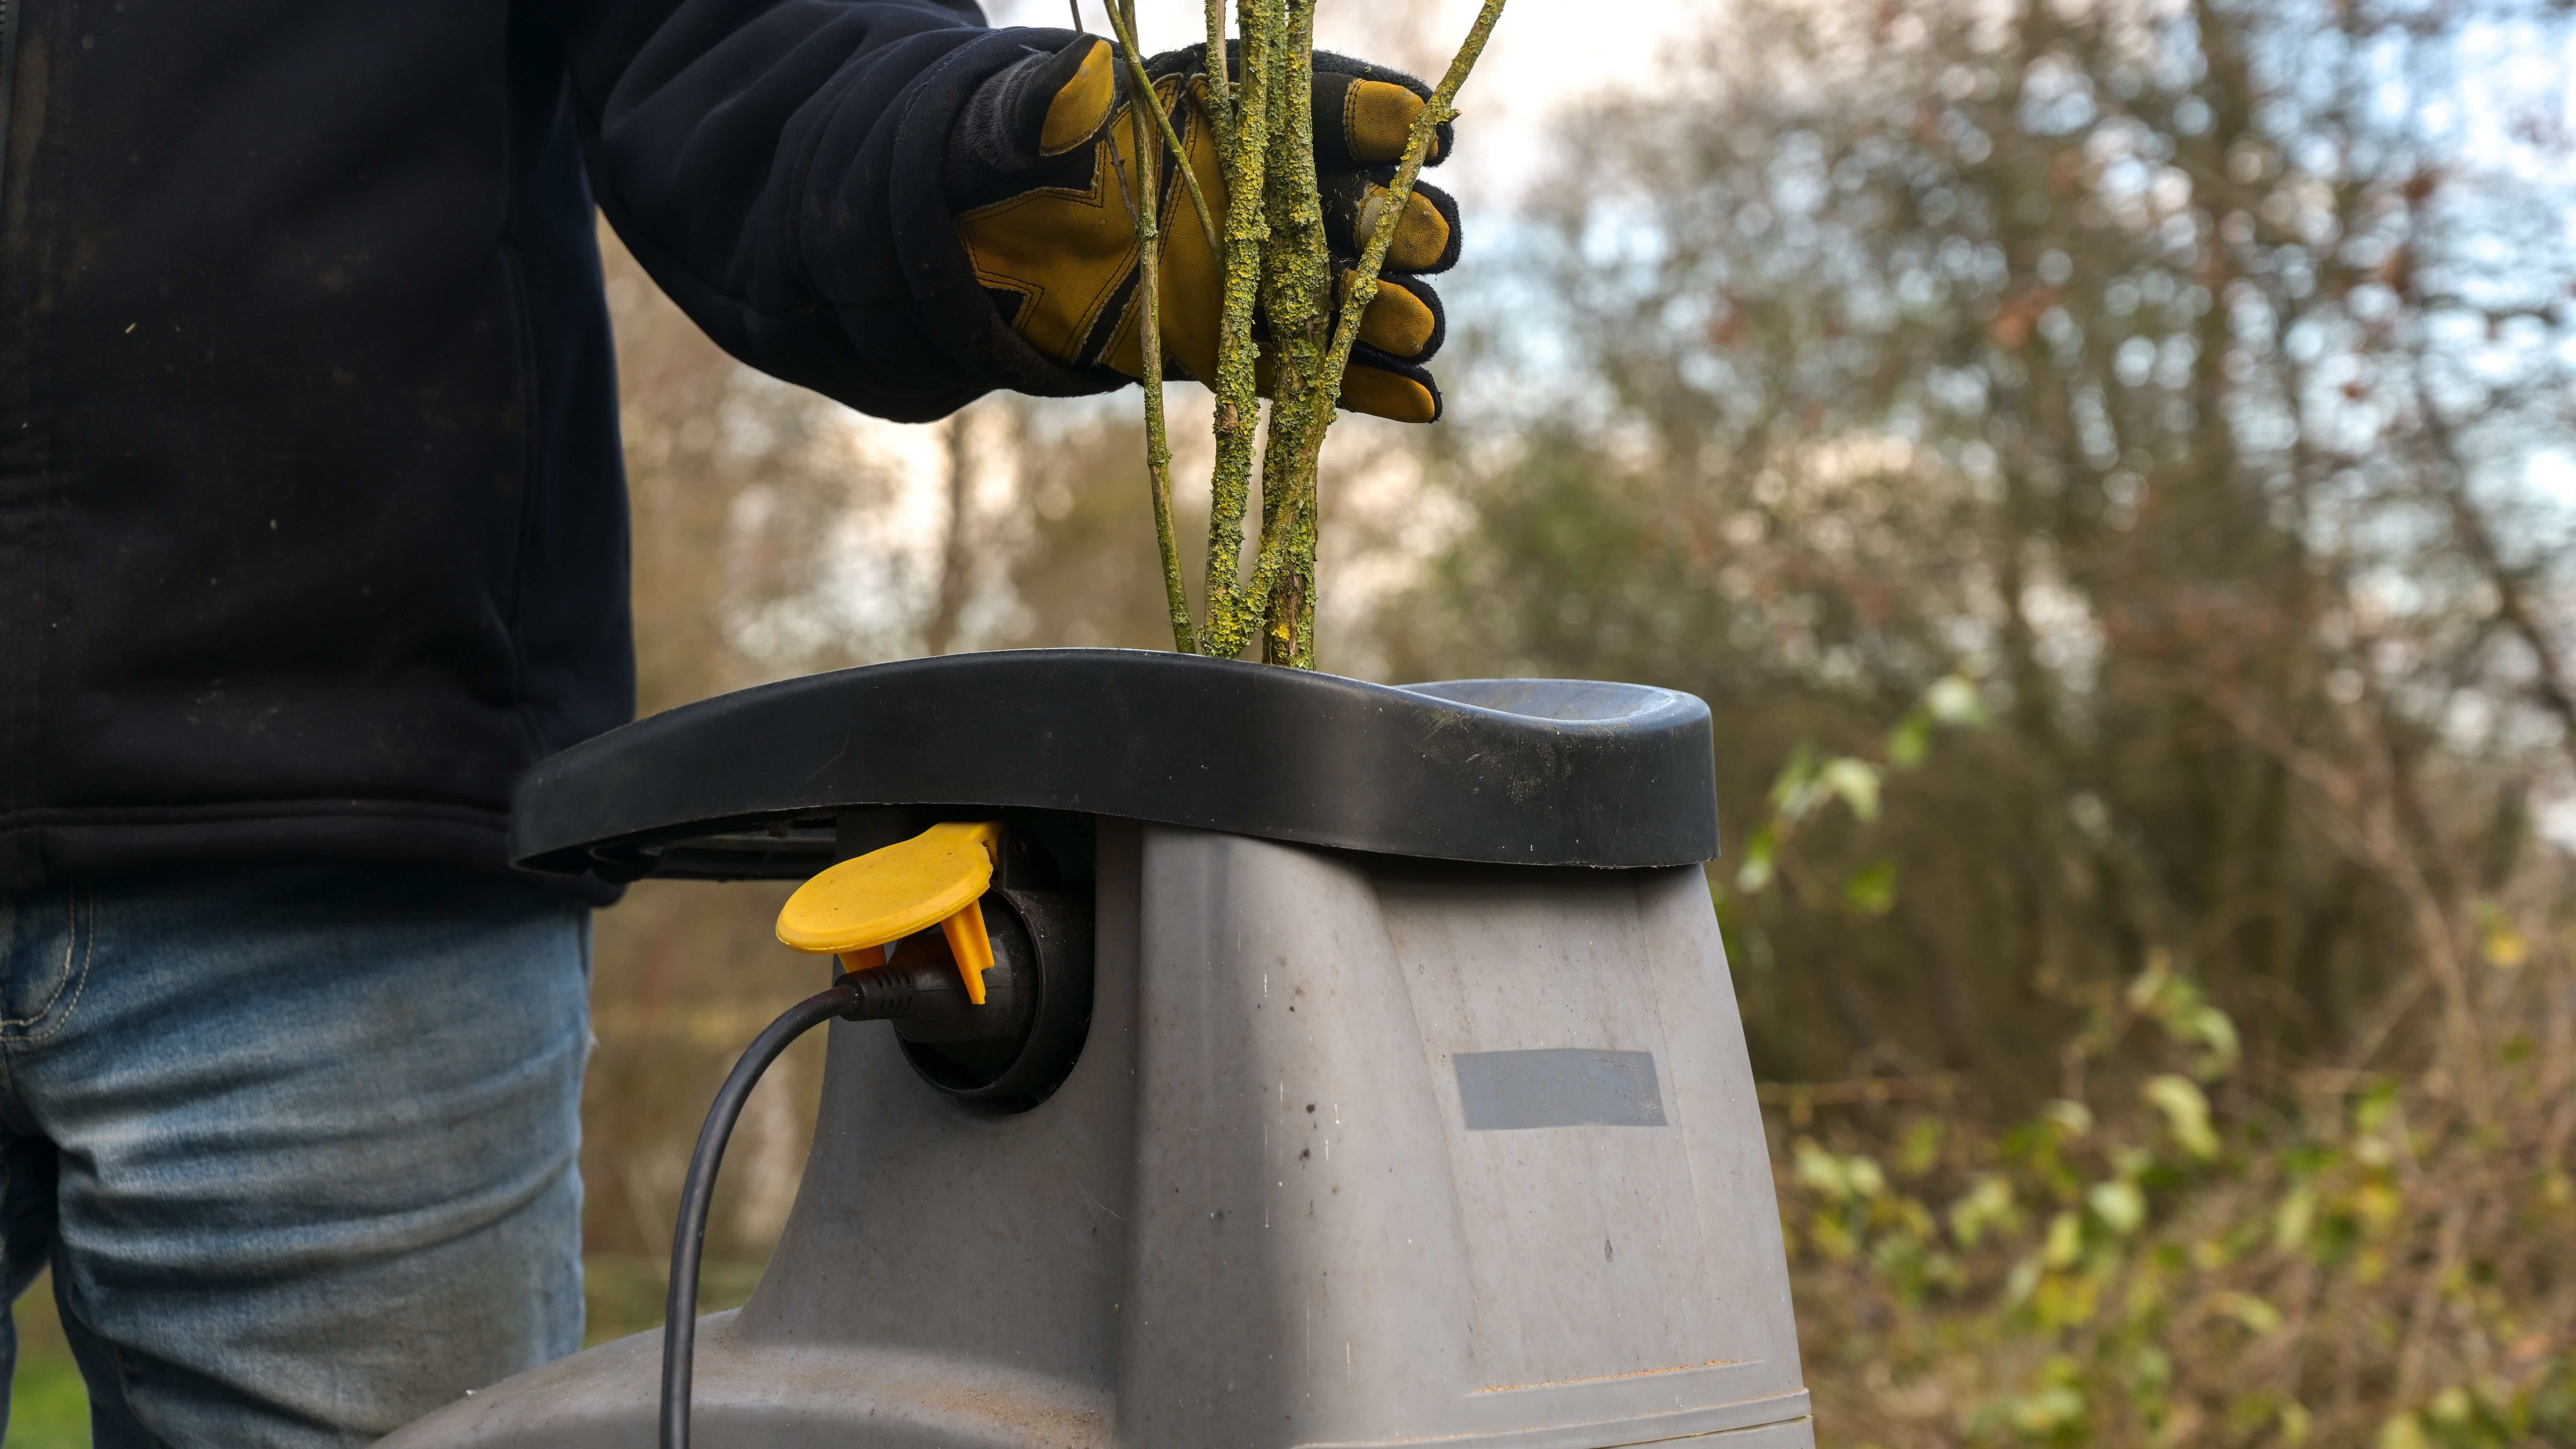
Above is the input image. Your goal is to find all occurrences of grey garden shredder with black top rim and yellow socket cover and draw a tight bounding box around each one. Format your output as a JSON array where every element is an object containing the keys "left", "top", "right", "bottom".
[{"left": 386, "top": 648, "right": 1814, "bottom": 1449}]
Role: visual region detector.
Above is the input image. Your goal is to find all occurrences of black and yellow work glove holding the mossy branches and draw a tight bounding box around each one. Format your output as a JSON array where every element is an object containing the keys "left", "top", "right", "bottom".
[{"left": 943, "top": 36, "right": 1458, "bottom": 422}]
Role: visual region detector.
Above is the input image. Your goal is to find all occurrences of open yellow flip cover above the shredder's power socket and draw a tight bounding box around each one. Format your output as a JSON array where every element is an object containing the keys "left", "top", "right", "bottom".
[{"left": 778, "top": 821, "right": 1002, "bottom": 1006}]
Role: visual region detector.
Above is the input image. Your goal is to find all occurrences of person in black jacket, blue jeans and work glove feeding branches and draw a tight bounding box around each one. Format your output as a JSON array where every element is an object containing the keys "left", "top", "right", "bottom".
[{"left": 0, "top": 0, "right": 1458, "bottom": 1447}]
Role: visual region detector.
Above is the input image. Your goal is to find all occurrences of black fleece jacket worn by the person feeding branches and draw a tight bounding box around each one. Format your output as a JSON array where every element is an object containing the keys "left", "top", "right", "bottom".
[{"left": 0, "top": 0, "right": 1113, "bottom": 891}]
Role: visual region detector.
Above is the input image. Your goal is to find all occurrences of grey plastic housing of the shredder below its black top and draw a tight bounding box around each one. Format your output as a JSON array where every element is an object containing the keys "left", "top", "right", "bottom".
[{"left": 386, "top": 818, "right": 1814, "bottom": 1449}]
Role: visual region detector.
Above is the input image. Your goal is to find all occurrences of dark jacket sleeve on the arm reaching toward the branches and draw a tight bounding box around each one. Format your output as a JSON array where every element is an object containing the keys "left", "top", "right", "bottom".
[{"left": 559, "top": 0, "right": 1116, "bottom": 422}]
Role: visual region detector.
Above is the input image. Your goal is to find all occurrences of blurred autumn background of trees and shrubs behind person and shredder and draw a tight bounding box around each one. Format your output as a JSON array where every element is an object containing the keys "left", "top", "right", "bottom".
[{"left": 15, "top": 0, "right": 2576, "bottom": 1449}]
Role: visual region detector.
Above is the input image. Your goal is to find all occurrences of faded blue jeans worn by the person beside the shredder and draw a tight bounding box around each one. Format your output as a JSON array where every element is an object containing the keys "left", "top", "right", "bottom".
[{"left": 0, "top": 865, "right": 590, "bottom": 1447}]
